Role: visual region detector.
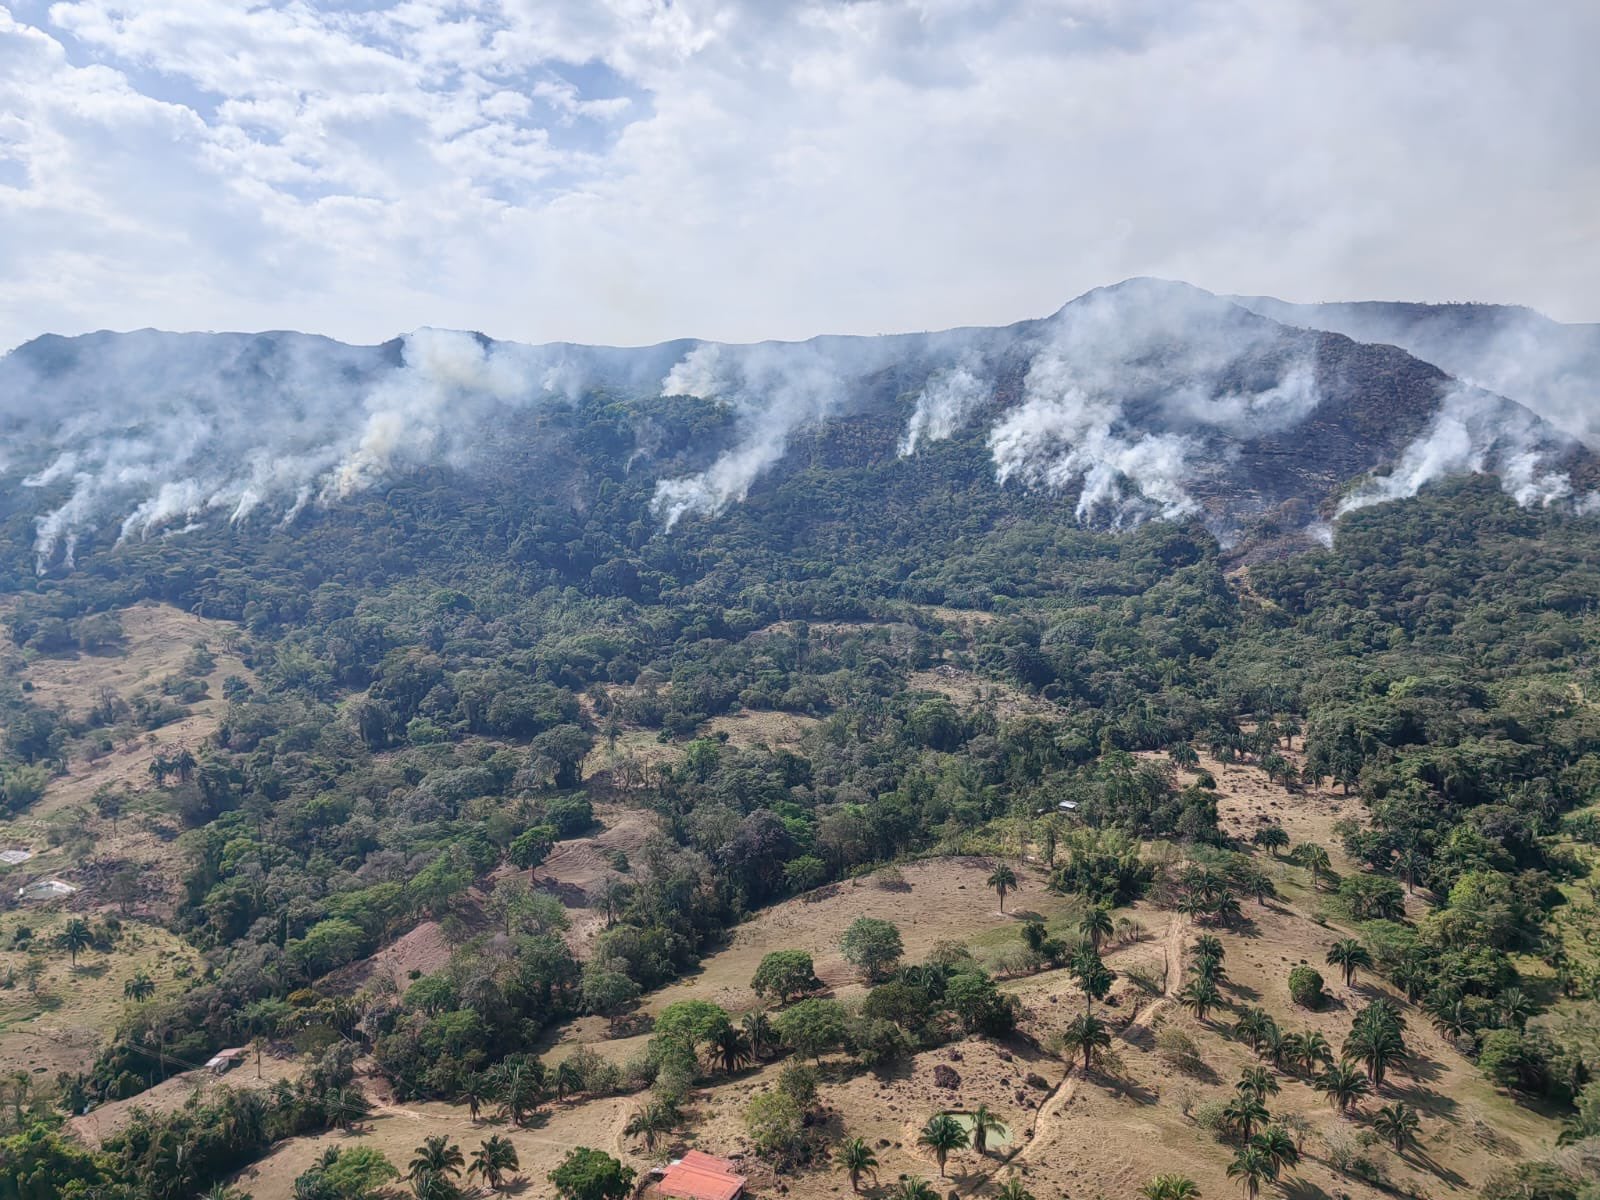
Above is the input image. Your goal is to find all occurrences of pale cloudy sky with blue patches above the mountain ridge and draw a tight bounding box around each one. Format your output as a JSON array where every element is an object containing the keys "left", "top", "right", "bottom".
[{"left": 0, "top": 0, "right": 1600, "bottom": 349}]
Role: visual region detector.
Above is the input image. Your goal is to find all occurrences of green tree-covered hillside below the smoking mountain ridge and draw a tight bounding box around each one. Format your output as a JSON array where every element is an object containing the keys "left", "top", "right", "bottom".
[{"left": 0, "top": 302, "right": 1600, "bottom": 1200}]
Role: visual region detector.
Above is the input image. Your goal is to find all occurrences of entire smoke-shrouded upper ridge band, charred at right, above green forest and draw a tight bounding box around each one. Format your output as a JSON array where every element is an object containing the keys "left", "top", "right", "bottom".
[{"left": 0, "top": 280, "right": 1592, "bottom": 571}]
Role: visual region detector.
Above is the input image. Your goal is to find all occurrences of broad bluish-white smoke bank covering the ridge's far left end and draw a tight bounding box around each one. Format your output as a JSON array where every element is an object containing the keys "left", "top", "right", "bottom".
[{"left": 9, "top": 330, "right": 550, "bottom": 570}]
